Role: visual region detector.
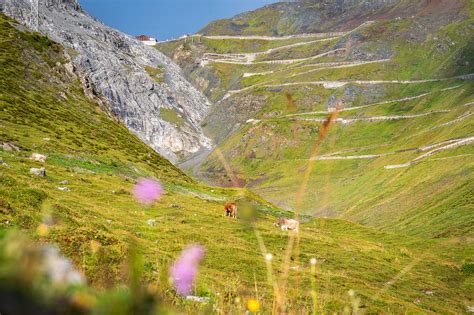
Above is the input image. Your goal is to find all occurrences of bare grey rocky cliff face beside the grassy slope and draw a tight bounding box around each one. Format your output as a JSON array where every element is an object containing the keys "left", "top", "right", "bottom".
[{"left": 3, "top": 0, "right": 212, "bottom": 161}]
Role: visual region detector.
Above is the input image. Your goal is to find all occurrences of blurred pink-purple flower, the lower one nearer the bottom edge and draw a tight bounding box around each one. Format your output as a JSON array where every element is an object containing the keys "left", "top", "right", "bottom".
[{"left": 171, "top": 245, "right": 204, "bottom": 296}]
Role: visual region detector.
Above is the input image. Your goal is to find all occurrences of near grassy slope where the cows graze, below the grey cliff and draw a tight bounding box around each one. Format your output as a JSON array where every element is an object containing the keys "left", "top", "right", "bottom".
[{"left": 0, "top": 14, "right": 474, "bottom": 314}]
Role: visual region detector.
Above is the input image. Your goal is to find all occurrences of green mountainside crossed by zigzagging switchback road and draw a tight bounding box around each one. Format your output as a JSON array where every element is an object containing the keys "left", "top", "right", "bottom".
[{"left": 159, "top": 1, "right": 474, "bottom": 237}]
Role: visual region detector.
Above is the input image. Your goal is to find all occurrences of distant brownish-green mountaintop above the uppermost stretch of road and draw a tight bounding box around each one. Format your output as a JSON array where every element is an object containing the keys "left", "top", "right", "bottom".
[{"left": 198, "top": 0, "right": 466, "bottom": 36}]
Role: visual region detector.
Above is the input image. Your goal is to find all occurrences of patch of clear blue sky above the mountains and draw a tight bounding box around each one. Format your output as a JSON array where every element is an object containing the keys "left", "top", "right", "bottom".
[{"left": 79, "top": 0, "right": 277, "bottom": 40}]
